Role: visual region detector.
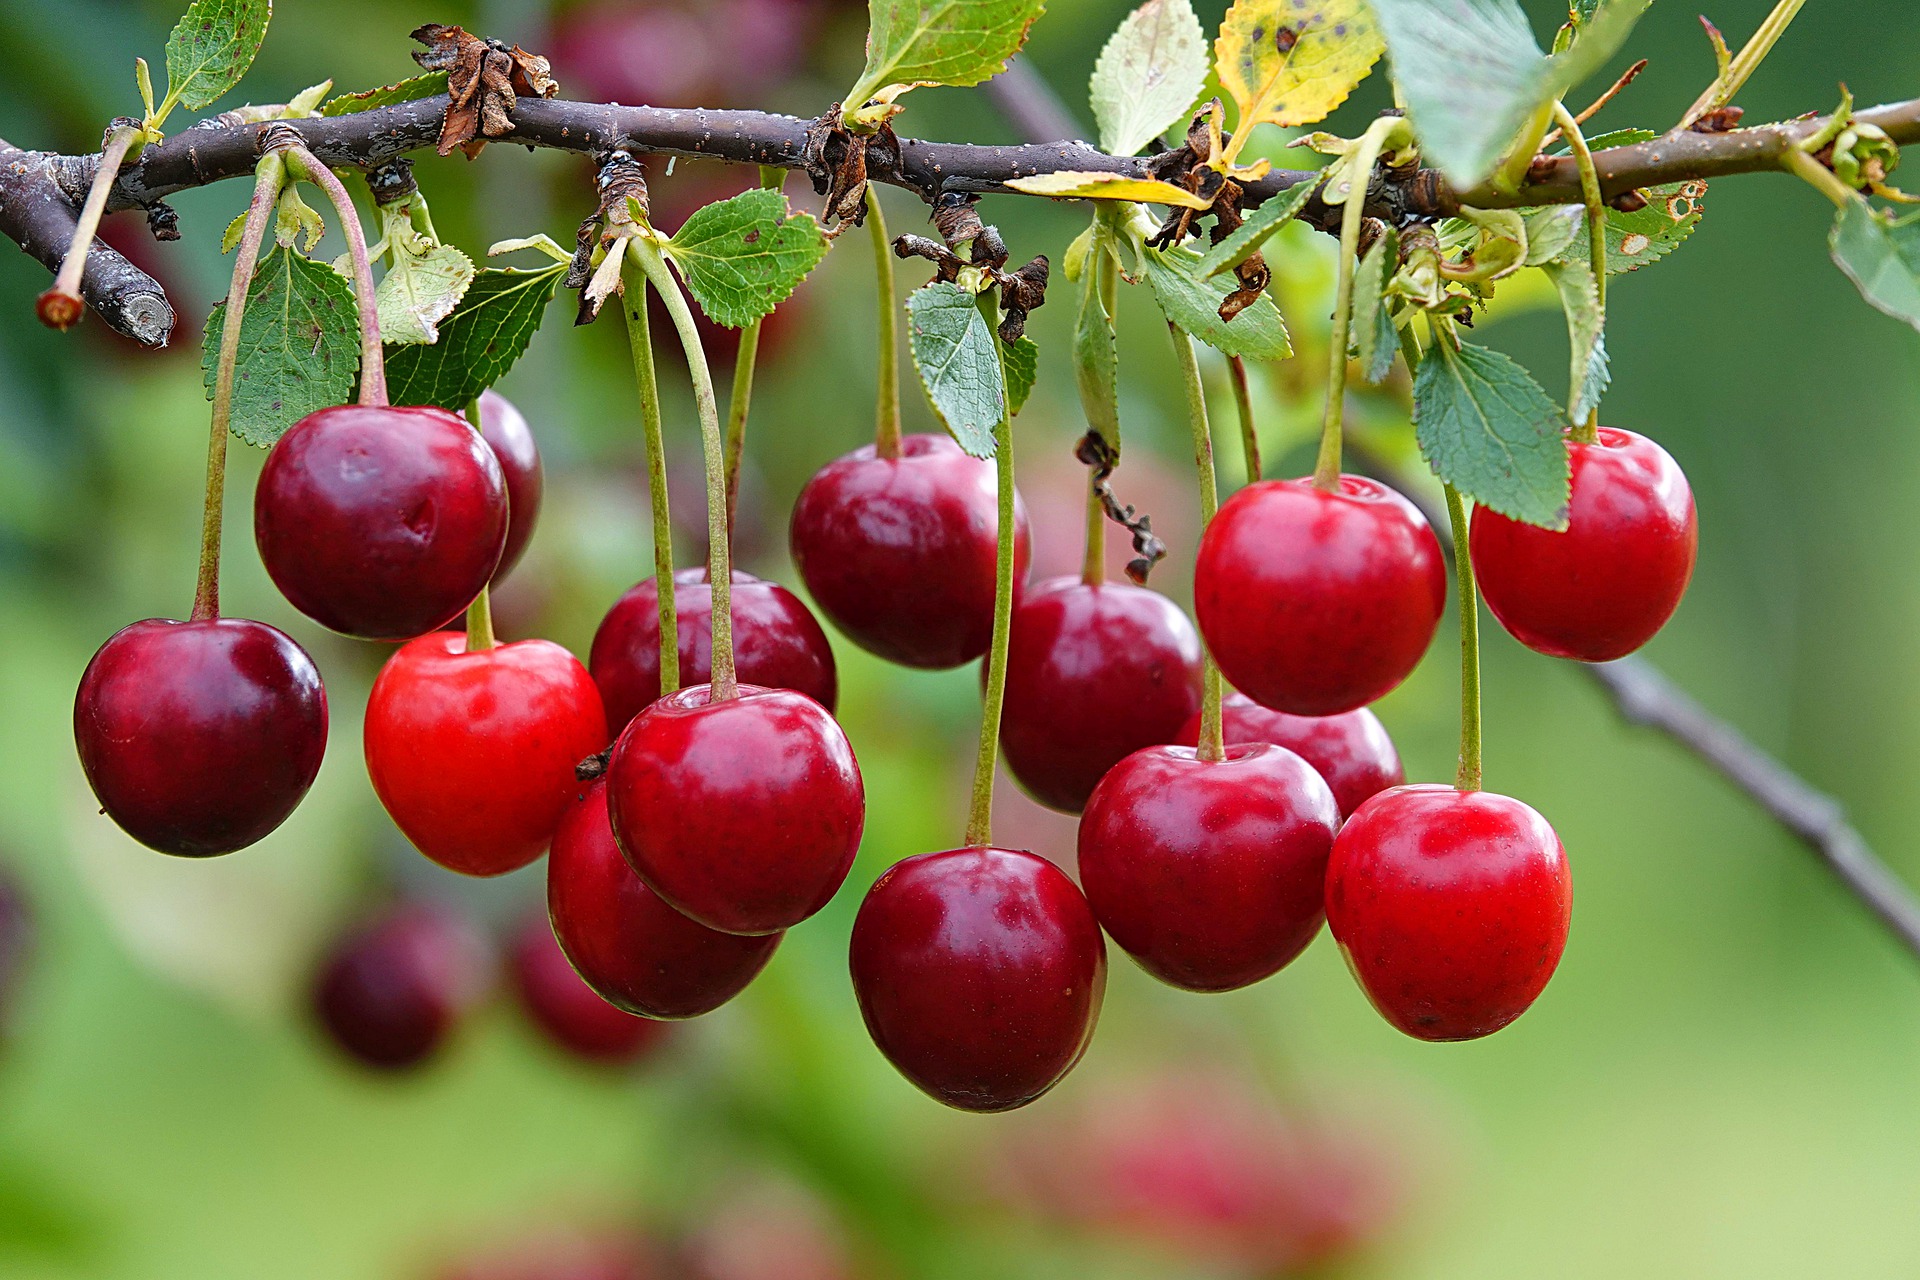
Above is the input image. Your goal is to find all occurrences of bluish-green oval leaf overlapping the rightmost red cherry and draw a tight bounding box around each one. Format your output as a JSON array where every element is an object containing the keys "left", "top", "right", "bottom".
[{"left": 1413, "top": 338, "right": 1569, "bottom": 530}]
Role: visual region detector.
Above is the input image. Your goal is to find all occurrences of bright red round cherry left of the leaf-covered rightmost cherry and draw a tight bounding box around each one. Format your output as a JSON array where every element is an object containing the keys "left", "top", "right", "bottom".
[{"left": 1194, "top": 476, "right": 1446, "bottom": 716}]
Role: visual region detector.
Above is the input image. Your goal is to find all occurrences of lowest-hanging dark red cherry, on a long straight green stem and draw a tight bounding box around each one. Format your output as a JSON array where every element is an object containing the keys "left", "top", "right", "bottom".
[{"left": 849, "top": 848, "right": 1106, "bottom": 1111}]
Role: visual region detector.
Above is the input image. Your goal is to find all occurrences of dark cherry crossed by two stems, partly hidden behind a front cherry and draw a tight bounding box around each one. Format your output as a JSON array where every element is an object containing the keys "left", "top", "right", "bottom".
[{"left": 588, "top": 568, "right": 839, "bottom": 735}]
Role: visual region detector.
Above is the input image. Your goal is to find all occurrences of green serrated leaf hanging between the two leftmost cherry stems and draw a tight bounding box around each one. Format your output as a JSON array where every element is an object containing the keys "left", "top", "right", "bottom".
[{"left": 200, "top": 246, "right": 359, "bottom": 449}]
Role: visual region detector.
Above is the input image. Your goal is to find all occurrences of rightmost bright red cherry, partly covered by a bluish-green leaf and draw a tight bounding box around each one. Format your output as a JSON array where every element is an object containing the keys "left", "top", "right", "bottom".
[{"left": 1467, "top": 428, "right": 1699, "bottom": 662}]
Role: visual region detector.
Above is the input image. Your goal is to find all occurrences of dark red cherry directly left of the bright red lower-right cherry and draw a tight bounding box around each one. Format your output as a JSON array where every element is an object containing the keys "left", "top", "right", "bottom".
[{"left": 1079, "top": 743, "right": 1340, "bottom": 990}]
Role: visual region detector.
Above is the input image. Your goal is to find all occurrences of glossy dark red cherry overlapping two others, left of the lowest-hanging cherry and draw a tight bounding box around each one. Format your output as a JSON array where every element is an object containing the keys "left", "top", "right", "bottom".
[{"left": 607, "top": 685, "right": 866, "bottom": 935}]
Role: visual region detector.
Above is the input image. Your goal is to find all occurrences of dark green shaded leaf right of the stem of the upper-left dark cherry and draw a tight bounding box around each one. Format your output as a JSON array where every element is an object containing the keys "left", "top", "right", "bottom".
[{"left": 386, "top": 263, "right": 566, "bottom": 409}]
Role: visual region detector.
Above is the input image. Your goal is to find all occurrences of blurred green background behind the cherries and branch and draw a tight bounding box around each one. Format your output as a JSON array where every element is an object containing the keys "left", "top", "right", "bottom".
[{"left": 0, "top": 0, "right": 1920, "bottom": 1280}]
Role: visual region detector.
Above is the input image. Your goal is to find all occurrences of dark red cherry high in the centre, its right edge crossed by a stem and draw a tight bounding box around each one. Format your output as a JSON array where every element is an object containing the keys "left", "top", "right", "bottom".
[{"left": 789, "top": 436, "right": 1031, "bottom": 670}]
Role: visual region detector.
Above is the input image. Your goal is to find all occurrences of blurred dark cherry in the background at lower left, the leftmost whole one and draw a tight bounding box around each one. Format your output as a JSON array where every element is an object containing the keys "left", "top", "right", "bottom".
[{"left": 313, "top": 904, "right": 490, "bottom": 1071}]
